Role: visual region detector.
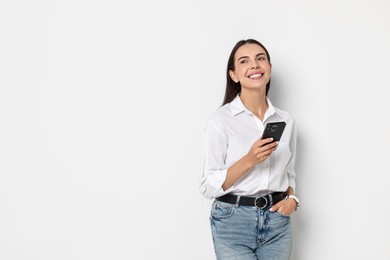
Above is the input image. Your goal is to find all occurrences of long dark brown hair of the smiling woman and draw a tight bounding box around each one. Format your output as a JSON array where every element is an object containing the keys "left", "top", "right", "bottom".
[{"left": 222, "top": 39, "right": 271, "bottom": 105}]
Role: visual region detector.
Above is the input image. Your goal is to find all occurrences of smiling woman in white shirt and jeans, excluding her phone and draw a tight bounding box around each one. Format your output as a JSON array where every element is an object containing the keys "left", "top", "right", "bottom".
[{"left": 200, "top": 39, "right": 299, "bottom": 260}]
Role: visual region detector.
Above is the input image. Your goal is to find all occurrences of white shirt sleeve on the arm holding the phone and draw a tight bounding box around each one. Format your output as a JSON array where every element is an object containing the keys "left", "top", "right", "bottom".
[{"left": 199, "top": 121, "right": 234, "bottom": 199}]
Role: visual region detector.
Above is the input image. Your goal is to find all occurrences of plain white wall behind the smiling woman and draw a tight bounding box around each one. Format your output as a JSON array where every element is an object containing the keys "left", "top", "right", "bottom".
[{"left": 0, "top": 0, "right": 390, "bottom": 260}]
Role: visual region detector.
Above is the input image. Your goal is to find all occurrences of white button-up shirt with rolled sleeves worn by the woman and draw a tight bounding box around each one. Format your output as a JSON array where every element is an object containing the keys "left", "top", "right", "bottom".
[{"left": 200, "top": 95, "right": 297, "bottom": 199}]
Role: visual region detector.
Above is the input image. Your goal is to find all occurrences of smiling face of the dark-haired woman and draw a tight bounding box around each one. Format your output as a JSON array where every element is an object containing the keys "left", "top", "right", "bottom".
[{"left": 229, "top": 43, "right": 271, "bottom": 90}]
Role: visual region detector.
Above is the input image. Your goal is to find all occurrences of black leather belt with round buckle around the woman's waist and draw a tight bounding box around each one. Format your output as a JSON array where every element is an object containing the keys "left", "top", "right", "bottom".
[{"left": 216, "top": 192, "right": 285, "bottom": 209}]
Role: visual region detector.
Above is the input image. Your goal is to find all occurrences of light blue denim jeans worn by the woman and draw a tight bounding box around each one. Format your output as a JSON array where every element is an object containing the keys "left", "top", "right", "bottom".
[{"left": 210, "top": 201, "right": 292, "bottom": 260}]
